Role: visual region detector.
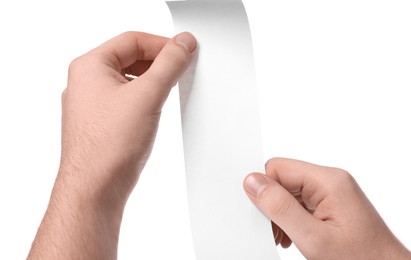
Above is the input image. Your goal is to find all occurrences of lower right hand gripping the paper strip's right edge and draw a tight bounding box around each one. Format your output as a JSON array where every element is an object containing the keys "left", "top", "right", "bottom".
[{"left": 244, "top": 158, "right": 411, "bottom": 260}]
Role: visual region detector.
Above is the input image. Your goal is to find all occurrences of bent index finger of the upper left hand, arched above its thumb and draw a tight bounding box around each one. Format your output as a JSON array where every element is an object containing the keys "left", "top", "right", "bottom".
[{"left": 91, "top": 32, "right": 169, "bottom": 72}]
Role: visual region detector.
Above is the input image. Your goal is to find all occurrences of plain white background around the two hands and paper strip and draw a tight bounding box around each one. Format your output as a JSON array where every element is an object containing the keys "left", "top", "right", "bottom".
[{"left": 0, "top": 0, "right": 411, "bottom": 260}]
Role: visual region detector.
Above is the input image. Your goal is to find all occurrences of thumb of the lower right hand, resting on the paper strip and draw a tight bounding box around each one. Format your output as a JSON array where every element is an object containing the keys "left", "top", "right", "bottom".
[{"left": 244, "top": 173, "right": 321, "bottom": 246}]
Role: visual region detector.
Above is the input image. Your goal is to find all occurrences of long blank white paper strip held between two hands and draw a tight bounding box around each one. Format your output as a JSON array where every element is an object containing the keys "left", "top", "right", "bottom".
[{"left": 167, "top": 1, "right": 279, "bottom": 260}]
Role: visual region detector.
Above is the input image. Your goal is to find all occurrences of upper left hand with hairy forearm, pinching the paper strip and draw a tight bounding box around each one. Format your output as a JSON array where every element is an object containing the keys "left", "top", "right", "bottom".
[{"left": 29, "top": 32, "right": 196, "bottom": 259}]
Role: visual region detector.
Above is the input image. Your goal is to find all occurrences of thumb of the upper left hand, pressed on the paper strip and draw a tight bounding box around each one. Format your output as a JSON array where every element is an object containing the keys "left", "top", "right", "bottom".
[{"left": 130, "top": 32, "right": 197, "bottom": 111}]
